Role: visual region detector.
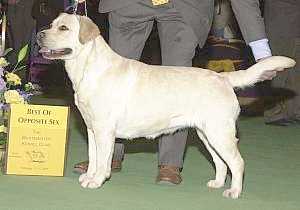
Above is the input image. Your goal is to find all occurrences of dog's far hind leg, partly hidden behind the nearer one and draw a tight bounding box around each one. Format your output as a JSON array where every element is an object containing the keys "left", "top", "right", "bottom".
[{"left": 197, "top": 129, "right": 227, "bottom": 188}]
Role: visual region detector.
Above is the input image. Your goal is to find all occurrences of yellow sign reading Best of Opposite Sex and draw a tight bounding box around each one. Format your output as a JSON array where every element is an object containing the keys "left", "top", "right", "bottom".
[{"left": 5, "top": 104, "right": 69, "bottom": 176}]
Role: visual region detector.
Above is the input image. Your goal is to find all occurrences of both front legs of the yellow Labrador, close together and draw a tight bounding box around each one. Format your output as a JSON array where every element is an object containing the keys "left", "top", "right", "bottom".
[{"left": 79, "top": 126, "right": 115, "bottom": 188}]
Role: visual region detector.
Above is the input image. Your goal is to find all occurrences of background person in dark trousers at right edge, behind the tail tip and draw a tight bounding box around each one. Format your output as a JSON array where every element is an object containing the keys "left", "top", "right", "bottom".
[{"left": 264, "top": 0, "right": 300, "bottom": 126}]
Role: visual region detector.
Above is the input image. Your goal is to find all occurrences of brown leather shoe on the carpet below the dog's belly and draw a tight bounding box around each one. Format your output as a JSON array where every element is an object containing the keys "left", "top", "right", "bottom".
[{"left": 156, "top": 165, "right": 182, "bottom": 185}]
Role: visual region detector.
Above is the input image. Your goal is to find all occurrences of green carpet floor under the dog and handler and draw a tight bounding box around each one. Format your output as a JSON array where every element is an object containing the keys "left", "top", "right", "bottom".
[{"left": 0, "top": 95, "right": 300, "bottom": 210}]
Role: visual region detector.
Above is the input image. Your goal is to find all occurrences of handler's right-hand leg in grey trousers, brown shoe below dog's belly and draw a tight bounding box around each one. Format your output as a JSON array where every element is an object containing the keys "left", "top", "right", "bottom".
[{"left": 157, "top": 5, "right": 198, "bottom": 184}]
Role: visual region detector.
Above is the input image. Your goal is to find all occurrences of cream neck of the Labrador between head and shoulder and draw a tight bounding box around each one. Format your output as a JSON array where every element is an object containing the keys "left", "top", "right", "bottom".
[{"left": 65, "top": 36, "right": 122, "bottom": 92}]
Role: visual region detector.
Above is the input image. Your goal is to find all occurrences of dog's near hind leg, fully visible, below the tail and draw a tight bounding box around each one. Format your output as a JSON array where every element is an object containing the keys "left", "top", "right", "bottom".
[{"left": 204, "top": 119, "right": 244, "bottom": 199}]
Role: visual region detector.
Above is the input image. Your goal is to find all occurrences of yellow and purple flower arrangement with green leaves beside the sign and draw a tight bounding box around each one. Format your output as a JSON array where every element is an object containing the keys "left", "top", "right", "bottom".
[{"left": 0, "top": 45, "right": 34, "bottom": 145}]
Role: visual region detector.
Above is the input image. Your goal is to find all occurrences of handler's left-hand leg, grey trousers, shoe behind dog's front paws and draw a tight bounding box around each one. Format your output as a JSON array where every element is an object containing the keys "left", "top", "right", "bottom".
[{"left": 74, "top": 3, "right": 153, "bottom": 173}]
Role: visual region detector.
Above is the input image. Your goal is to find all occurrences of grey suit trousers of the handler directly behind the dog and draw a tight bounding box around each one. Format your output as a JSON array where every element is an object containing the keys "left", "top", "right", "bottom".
[{"left": 109, "top": 1, "right": 198, "bottom": 168}]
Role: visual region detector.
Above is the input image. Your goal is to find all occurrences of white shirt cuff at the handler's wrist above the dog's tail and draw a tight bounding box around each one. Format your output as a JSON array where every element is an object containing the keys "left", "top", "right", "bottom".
[{"left": 249, "top": 39, "right": 272, "bottom": 61}]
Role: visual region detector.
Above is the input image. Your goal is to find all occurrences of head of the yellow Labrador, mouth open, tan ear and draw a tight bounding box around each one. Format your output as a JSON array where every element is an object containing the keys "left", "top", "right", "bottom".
[{"left": 37, "top": 13, "right": 100, "bottom": 60}]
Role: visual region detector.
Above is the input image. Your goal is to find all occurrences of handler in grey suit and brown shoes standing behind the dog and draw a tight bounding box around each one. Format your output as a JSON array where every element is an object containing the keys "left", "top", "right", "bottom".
[{"left": 75, "top": 0, "right": 271, "bottom": 184}]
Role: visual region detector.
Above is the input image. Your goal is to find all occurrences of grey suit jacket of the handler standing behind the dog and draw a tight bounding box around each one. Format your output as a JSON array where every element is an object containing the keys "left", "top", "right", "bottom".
[{"left": 99, "top": 0, "right": 266, "bottom": 46}]
